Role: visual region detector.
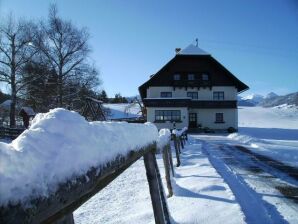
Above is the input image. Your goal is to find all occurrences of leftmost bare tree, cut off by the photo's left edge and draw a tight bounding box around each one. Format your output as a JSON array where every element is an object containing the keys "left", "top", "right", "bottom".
[{"left": 0, "top": 15, "right": 37, "bottom": 127}]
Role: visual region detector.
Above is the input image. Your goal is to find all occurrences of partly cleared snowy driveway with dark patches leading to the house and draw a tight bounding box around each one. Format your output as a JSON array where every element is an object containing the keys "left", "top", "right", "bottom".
[{"left": 197, "top": 140, "right": 298, "bottom": 223}]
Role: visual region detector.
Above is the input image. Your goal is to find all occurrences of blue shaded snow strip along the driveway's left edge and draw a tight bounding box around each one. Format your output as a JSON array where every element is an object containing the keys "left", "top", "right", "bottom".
[{"left": 198, "top": 140, "right": 288, "bottom": 224}]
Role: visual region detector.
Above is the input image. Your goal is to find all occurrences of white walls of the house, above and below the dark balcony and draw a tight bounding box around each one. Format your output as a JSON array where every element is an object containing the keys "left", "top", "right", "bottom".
[{"left": 147, "top": 86, "right": 238, "bottom": 130}]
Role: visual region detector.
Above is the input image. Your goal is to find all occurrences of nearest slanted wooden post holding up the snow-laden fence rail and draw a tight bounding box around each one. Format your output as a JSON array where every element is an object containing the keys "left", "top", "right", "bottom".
[{"left": 144, "top": 152, "right": 168, "bottom": 224}]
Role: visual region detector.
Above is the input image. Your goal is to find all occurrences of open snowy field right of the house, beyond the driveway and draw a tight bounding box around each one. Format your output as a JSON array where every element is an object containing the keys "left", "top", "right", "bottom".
[{"left": 235, "top": 105, "right": 298, "bottom": 167}]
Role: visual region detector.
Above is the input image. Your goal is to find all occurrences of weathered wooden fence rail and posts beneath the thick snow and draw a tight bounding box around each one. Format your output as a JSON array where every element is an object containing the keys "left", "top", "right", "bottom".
[{"left": 0, "top": 129, "right": 187, "bottom": 224}]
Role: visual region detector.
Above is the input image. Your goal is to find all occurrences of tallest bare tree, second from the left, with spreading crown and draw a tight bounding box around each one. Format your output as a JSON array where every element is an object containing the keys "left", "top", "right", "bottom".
[{"left": 36, "top": 5, "right": 90, "bottom": 107}]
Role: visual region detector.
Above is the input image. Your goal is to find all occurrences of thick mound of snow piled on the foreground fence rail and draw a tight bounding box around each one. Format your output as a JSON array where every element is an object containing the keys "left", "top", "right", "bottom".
[{"left": 0, "top": 108, "right": 158, "bottom": 205}]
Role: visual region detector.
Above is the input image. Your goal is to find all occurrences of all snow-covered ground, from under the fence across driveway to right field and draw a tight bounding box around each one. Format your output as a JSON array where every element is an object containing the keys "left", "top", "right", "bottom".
[{"left": 0, "top": 105, "right": 298, "bottom": 224}]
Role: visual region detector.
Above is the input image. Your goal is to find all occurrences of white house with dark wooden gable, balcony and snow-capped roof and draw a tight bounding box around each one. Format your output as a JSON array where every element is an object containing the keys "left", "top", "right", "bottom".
[{"left": 139, "top": 45, "right": 248, "bottom": 130}]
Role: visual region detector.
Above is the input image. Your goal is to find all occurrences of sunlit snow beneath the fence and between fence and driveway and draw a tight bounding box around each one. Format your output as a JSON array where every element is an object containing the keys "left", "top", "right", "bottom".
[{"left": 74, "top": 141, "right": 245, "bottom": 224}]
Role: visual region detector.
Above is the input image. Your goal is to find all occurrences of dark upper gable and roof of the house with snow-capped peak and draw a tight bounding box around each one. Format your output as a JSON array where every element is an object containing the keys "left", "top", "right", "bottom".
[{"left": 139, "top": 45, "right": 249, "bottom": 98}]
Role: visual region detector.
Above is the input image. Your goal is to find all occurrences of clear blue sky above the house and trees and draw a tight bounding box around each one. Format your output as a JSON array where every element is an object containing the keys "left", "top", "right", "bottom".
[{"left": 0, "top": 0, "right": 298, "bottom": 96}]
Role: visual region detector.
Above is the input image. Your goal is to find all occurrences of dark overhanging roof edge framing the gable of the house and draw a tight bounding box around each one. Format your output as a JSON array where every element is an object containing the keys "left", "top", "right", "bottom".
[{"left": 139, "top": 49, "right": 249, "bottom": 98}]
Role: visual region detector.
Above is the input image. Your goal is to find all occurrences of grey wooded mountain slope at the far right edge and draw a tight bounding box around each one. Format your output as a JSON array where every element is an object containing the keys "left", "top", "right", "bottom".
[{"left": 259, "top": 92, "right": 298, "bottom": 107}]
